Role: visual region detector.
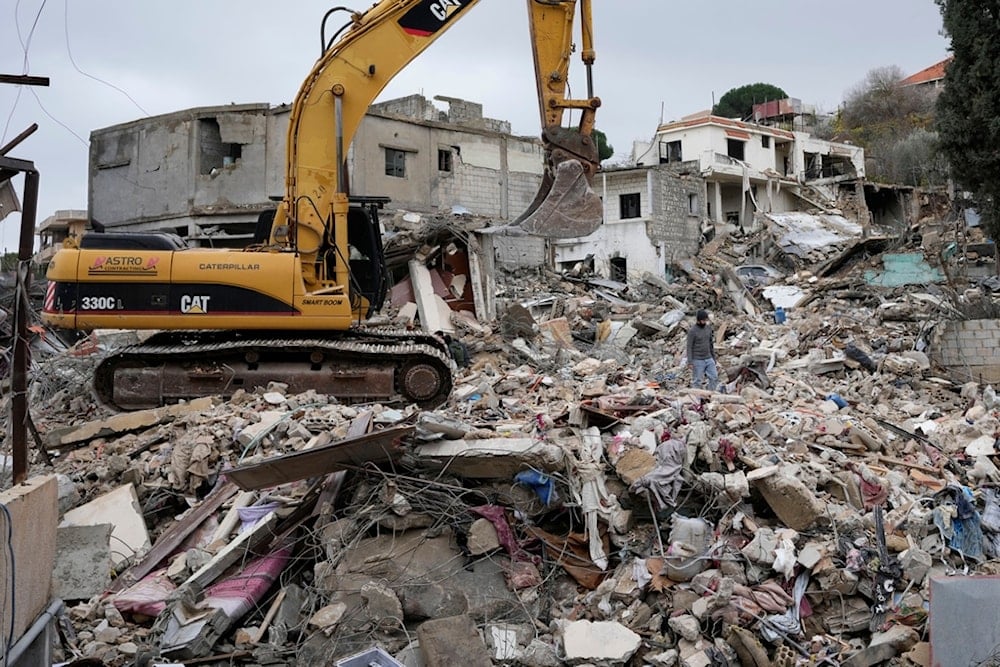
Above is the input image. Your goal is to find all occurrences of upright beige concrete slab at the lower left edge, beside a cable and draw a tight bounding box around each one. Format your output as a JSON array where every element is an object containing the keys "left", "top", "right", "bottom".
[{"left": 0, "top": 475, "right": 59, "bottom": 641}]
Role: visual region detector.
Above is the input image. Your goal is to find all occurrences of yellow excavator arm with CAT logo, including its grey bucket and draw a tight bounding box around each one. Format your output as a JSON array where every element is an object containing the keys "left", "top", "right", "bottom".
[{"left": 271, "top": 0, "right": 602, "bottom": 291}]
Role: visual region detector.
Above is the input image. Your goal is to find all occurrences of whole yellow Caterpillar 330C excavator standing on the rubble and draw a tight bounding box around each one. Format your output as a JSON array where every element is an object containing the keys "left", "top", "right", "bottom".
[{"left": 42, "top": 0, "right": 602, "bottom": 410}]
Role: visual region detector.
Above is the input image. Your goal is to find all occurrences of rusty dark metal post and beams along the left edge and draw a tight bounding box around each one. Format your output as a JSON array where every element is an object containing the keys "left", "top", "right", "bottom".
[{"left": 0, "top": 74, "right": 49, "bottom": 485}]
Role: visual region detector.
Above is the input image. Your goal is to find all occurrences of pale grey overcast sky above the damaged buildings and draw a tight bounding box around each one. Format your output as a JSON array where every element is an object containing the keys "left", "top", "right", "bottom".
[{"left": 0, "top": 0, "right": 948, "bottom": 251}]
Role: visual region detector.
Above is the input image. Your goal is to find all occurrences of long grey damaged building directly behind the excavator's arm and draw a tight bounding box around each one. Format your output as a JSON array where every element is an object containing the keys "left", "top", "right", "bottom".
[{"left": 88, "top": 95, "right": 556, "bottom": 247}]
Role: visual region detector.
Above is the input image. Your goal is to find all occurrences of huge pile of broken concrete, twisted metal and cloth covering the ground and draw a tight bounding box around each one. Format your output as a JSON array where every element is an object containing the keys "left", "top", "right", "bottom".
[{"left": 1, "top": 218, "right": 1000, "bottom": 667}]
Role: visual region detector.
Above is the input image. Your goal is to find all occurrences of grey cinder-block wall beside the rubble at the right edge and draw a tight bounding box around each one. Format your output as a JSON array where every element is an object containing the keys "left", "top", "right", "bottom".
[{"left": 932, "top": 320, "right": 1000, "bottom": 385}]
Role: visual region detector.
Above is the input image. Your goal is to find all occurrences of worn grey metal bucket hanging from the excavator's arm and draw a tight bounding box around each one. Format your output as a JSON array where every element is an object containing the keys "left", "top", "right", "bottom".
[{"left": 516, "top": 160, "right": 604, "bottom": 239}]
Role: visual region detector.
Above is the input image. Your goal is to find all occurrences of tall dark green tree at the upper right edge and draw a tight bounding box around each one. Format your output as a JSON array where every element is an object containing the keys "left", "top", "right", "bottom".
[{"left": 935, "top": 0, "right": 1000, "bottom": 239}]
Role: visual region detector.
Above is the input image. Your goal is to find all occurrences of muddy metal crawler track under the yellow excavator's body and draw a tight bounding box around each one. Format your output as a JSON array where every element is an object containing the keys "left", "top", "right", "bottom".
[{"left": 94, "top": 329, "right": 454, "bottom": 410}]
